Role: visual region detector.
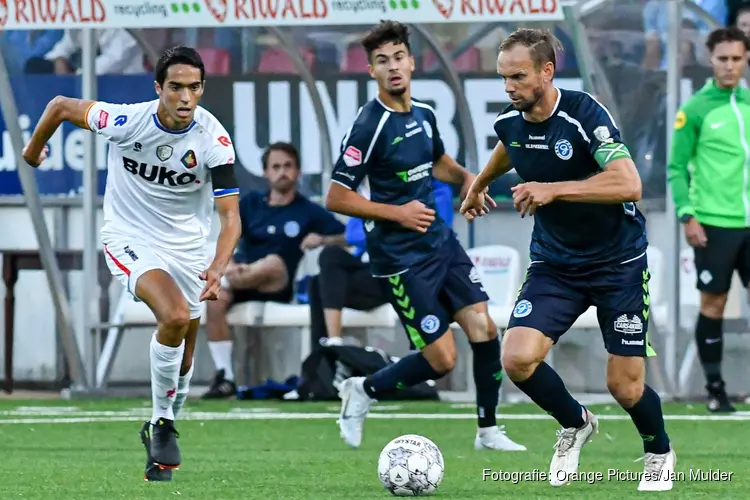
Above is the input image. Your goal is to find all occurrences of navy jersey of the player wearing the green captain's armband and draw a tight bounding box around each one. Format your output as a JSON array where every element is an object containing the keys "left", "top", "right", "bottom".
[{"left": 494, "top": 89, "right": 648, "bottom": 268}]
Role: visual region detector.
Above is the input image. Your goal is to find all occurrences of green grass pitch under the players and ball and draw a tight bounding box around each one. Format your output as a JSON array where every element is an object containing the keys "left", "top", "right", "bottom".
[{"left": 0, "top": 400, "right": 750, "bottom": 500}]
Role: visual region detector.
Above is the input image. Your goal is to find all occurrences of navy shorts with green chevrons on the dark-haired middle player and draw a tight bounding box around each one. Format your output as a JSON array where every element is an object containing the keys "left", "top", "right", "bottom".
[{"left": 378, "top": 235, "right": 489, "bottom": 350}]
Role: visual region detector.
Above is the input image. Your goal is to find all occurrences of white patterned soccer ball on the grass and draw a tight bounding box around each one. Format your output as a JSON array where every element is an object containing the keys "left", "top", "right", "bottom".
[{"left": 378, "top": 434, "right": 445, "bottom": 497}]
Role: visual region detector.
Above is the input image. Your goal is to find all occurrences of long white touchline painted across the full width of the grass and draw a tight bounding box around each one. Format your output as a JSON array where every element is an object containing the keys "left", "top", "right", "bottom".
[{"left": 0, "top": 412, "right": 750, "bottom": 424}]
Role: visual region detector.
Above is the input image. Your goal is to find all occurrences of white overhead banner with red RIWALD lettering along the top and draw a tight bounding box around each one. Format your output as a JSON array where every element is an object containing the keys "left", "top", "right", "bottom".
[{"left": 0, "top": 0, "right": 563, "bottom": 29}]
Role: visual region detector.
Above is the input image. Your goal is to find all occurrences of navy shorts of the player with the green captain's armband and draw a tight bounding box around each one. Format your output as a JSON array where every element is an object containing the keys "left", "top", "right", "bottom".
[{"left": 508, "top": 254, "right": 656, "bottom": 357}]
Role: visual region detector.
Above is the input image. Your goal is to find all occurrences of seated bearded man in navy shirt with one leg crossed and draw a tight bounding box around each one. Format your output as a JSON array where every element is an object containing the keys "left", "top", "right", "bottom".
[{"left": 203, "top": 142, "right": 345, "bottom": 399}]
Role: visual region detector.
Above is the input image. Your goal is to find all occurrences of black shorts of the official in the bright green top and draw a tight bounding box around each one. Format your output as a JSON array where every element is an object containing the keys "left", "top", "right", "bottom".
[{"left": 694, "top": 225, "right": 750, "bottom": 294}]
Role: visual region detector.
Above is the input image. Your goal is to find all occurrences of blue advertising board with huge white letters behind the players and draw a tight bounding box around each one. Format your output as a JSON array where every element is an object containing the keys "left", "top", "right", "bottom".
[{"left": 0, "top": 73, "right": 707, "bottom": 199}]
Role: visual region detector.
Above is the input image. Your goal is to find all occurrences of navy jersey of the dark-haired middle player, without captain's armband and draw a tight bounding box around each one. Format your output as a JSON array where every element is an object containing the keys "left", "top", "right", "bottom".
[{"left": 331, "top": 98, "right": 452, "bottom": 276}]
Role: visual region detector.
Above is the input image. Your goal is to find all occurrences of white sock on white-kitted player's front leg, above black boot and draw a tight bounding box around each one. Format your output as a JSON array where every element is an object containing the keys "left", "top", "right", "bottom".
[{"left": 149, "top": 332, "right": 185, "bottom": 424}]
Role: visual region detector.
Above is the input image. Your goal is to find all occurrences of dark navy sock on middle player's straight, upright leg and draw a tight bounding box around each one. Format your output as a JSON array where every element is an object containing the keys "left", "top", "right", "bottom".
[{"left": 471, "top": 337, "right": 503, "bottom": 428}]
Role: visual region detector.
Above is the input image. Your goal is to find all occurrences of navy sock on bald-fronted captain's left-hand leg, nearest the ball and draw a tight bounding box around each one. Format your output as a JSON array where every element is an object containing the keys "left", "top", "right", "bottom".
[{"left": 514, "top": 361, "right": 586, "bottom": 429}]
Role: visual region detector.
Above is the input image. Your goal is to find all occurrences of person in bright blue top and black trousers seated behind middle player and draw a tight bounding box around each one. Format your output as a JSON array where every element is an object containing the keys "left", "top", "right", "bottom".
[{"left": 308, "top": 179, "right": 453, "bottom": 346}]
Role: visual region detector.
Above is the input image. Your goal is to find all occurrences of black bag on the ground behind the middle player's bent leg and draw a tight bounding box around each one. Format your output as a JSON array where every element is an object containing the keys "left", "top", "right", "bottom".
[{"left": 297, "top": 346, "right": 439, "bottom": 401}]
